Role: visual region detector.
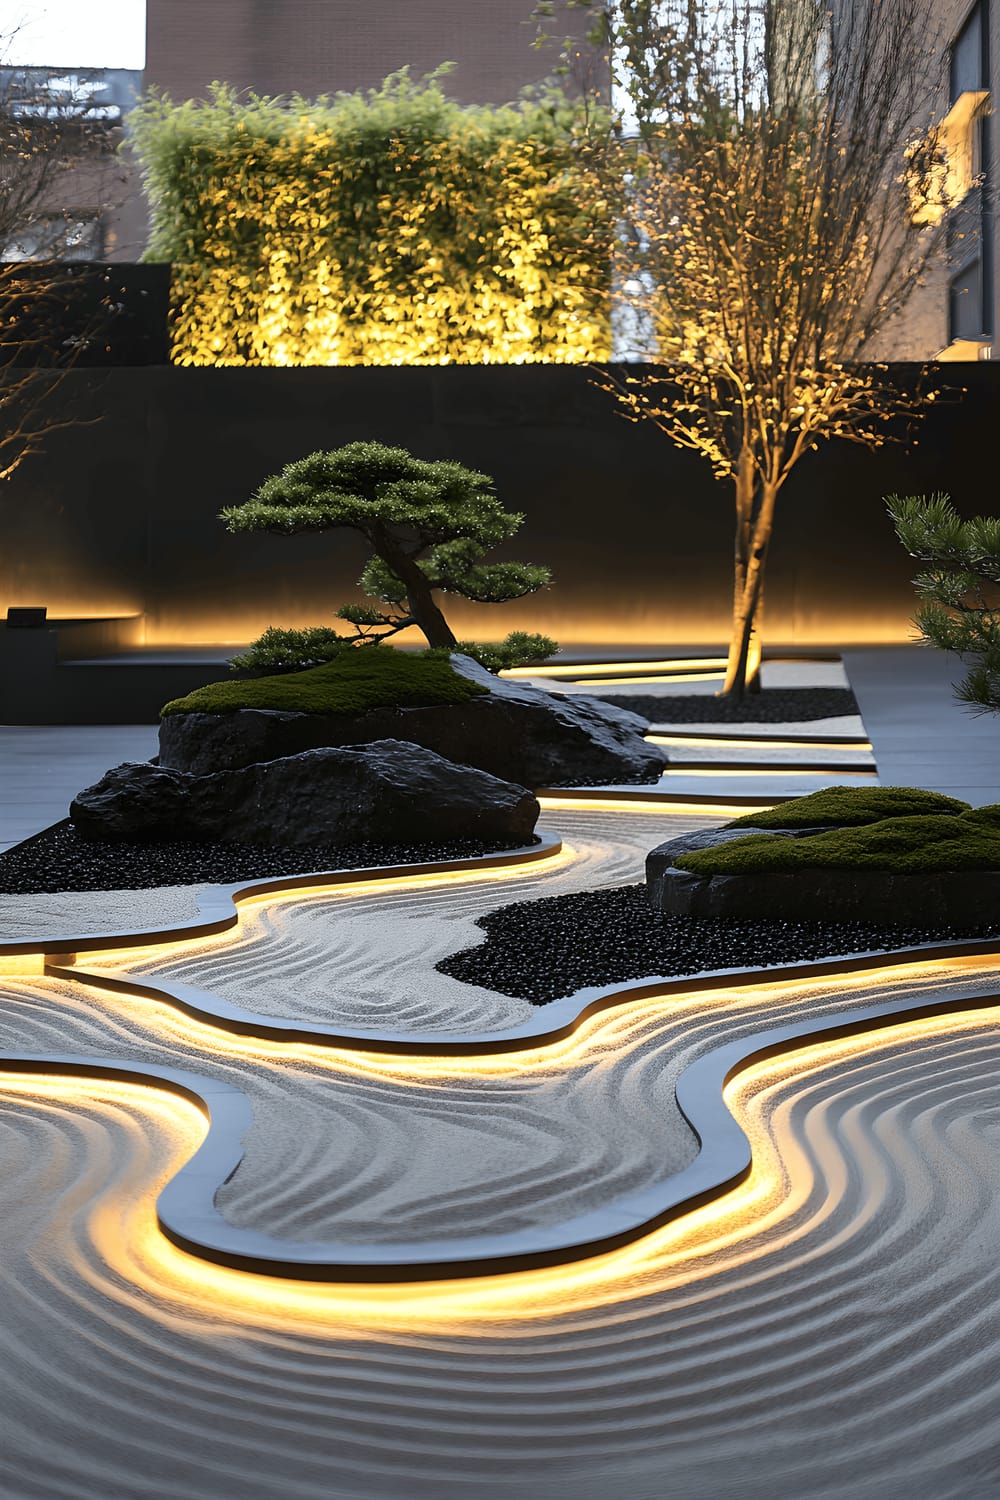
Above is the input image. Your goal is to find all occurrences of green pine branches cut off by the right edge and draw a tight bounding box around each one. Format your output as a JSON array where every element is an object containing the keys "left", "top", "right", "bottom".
[{"left": 886, "top": 495, "right": 1000, "bottom": 713}]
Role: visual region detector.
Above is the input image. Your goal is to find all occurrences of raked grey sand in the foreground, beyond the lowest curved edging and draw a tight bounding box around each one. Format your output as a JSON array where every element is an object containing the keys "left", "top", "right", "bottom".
[{"left": 0, "top": 1014, "right": 1000, "bottom": 1500}]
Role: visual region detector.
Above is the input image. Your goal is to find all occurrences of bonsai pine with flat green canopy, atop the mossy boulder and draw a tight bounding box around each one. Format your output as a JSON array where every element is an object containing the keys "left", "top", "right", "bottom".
[{"left": 220, "top": 443, "right": 556, "bottom": 669}]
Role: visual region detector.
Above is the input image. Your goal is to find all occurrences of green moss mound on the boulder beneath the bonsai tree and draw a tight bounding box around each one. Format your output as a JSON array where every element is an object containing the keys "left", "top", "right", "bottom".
[{"left": 160, "top": 647, "right": 487, "bottom": 719}]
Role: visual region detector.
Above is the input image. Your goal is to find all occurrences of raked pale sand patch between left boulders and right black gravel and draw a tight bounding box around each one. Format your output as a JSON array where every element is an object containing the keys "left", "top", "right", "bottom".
[{"left": 132, "top": 809, "right": 710, "bottom": 1032}]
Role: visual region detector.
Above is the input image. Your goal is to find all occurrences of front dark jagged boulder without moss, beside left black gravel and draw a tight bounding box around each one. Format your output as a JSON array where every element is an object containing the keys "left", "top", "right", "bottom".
[{"left": 69, "top": 740, "right": 538, "bottom": 846}]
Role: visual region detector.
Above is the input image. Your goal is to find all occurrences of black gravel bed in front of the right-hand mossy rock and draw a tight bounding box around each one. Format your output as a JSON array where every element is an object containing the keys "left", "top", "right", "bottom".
[{"left": 438, "top": 885, "right": 1000, "bottom": 1005}]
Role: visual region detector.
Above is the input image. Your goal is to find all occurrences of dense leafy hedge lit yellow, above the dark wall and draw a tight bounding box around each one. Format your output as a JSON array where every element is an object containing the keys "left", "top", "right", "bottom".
[{"left": 130, "top": 74, "right": 615, "bottom": 365}]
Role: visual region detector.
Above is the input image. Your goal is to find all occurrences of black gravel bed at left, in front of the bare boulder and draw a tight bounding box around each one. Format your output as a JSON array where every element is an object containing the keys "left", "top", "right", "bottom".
[{"left": 0, "top": 821, "right": 540, "bottom": 896}]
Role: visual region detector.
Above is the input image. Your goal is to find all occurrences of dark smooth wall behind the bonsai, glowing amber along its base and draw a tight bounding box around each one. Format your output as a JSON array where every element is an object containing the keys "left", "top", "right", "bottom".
[{"left": 0, "top": 363, "right": 1000, "bottom": 645}]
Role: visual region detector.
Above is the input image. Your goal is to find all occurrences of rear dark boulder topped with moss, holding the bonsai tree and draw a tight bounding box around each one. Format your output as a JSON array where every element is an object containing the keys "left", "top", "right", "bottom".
[{"left": 159, "top": 656, "right": 666, "bottom": 788}]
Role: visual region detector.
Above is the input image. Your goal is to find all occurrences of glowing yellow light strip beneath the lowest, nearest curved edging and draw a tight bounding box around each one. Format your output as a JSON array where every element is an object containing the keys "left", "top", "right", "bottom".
[{"left": 30, "top": 1013, "right": 977, "bottom": 1341}]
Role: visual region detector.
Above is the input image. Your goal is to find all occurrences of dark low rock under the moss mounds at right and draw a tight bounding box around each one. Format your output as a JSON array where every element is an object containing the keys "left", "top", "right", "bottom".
[{"left": 646, "top": 827, "right": 1000, "bottom": 927}]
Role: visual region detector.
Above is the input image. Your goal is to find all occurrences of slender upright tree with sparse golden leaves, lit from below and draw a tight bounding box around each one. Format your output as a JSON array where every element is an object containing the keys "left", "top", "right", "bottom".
[{"left": 543, "top": 0, "right": 942, "bottom": 698}]
